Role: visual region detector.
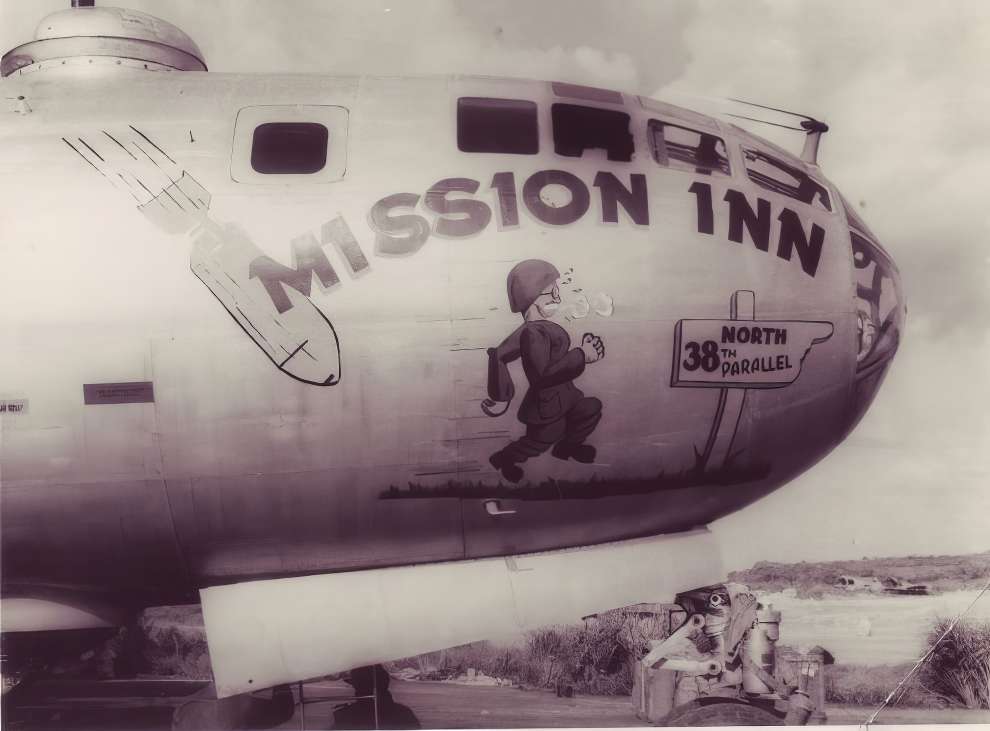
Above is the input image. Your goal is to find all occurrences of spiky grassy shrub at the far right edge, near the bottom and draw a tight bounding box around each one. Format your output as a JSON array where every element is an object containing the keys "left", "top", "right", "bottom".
[{"left": 921, "top": 619, "right": 990, "bottom": 709}]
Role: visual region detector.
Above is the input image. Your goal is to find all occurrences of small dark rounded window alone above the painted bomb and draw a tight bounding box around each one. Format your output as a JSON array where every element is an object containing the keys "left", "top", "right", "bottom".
[{"left": 251, "top": 122, "right": 330, "bottom": 175}]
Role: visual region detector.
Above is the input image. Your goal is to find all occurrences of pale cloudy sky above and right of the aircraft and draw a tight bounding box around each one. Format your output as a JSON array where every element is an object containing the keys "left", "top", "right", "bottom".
[{"left": 0, "top": 0, "right": 990, "bottom": 569}]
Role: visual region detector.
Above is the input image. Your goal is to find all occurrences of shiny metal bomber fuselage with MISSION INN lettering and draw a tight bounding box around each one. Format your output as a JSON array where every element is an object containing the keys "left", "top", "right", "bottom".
[{"left": 0, "top": 72, "right": 903, "bottom": 624}]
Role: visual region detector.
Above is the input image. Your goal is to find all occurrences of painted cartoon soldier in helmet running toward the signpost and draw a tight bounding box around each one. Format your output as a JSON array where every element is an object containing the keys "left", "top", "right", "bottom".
[{"left": 482, "top": 259, "right": 605, "bottom": 482}]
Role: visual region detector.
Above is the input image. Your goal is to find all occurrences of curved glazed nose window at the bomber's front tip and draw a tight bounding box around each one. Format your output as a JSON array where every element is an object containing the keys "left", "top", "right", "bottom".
[{"left": 850, "top": 231, "right": 904, "bottom": 372}]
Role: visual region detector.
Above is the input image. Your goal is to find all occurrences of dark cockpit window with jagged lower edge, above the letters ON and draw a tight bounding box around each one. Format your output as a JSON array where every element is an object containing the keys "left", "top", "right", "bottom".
[{"left": 551, "top": 104, "right": 634, "bottom": 162}]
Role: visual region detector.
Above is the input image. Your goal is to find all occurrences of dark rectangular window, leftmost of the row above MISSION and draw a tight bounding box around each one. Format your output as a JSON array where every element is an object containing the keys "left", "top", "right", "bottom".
[{"left": 457, "top": 97, "right": 540, "bottom": 155}]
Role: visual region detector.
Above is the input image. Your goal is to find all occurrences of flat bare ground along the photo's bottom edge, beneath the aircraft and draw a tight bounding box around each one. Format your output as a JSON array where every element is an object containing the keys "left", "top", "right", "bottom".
[{"left": 3, "top": 680, "right": 990, "bottom": 731}]
